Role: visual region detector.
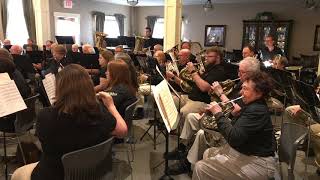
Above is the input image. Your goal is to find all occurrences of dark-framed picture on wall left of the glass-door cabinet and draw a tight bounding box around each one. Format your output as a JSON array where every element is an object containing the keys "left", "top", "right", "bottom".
[{"left": 204, "top": 25, "right": 226, "bottom": 47}]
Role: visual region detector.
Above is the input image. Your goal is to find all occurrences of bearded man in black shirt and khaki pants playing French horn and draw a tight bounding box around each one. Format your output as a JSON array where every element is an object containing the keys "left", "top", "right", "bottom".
[{"left": 176, "top": 47, "right": 226, "bottom": 118}]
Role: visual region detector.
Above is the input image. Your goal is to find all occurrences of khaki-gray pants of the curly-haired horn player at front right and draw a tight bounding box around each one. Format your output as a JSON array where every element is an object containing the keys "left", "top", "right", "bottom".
[{"left": 192, "top": 144, "right": 280, "bottom": 180}]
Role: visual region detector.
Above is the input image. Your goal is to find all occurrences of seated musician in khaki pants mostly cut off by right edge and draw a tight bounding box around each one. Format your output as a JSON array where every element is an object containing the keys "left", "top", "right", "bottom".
[{"left": 284, "top": 76, "right": 320, "bottom": 175}]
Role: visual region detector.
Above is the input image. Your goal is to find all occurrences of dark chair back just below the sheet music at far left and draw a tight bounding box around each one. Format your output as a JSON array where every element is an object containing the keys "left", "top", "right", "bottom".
[{"left": 14, "top": 94, "right": 39, "bottom": 133}]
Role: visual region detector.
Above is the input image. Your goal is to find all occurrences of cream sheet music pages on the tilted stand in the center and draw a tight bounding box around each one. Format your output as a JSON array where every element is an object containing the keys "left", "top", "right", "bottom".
[{"left": 152, "top": 80, "right": 179, "bottom": 132}]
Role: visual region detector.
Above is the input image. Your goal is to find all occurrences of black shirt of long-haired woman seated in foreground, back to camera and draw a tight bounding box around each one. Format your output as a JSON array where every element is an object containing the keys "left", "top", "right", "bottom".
[{"left": 31, "top": 108, "right": 116, "bottom": 180}]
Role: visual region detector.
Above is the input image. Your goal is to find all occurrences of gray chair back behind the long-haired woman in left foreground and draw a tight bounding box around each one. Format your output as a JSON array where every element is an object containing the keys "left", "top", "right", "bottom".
[{"left": 61, "top": 138, "right": 113, "bottom": 180}]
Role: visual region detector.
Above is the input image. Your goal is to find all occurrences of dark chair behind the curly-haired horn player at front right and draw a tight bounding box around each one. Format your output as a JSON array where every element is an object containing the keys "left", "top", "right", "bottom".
[{"left": 278, "top": 123, "right": 309, "bottom": 180}]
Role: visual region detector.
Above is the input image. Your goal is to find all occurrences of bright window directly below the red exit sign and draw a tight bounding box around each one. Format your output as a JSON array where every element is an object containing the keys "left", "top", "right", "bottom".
[{"left": 54, "top": 12, "right": 80, "bottom": 44}]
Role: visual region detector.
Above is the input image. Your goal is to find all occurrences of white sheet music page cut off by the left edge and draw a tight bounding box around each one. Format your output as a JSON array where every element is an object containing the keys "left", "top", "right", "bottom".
[{"left": 0, "top": 80, "right": 27, "bottom": 117}]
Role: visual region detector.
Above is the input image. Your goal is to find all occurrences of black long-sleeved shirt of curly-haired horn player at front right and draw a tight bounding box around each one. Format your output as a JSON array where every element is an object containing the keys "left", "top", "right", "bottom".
[{"left": 215, "top": 100, "right": 276, "bottom": 157}]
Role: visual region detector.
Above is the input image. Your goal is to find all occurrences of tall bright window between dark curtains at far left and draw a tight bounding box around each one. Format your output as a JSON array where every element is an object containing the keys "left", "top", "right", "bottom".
[{"left": 6, "top": 0, "right": 29, "bottom": 46}]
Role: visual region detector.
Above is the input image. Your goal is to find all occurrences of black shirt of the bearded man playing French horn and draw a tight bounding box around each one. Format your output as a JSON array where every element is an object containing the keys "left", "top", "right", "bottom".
[{"left": 189, "top": 64, "right": 227, "bottom": 104}]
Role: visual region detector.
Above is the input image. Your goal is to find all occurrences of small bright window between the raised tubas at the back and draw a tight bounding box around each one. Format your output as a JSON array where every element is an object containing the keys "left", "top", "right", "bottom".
[{"left": 103, "top": 16, "right": 120, "bottom": 38}]
